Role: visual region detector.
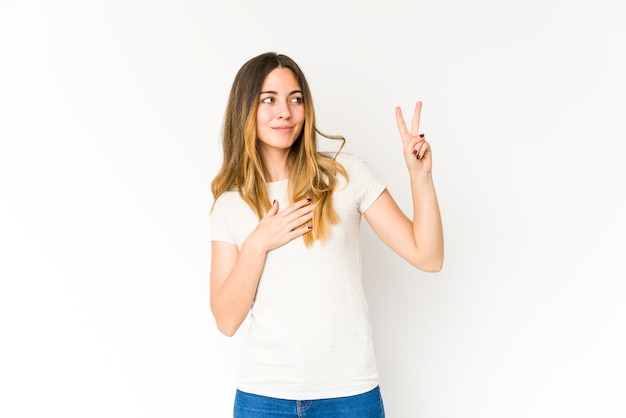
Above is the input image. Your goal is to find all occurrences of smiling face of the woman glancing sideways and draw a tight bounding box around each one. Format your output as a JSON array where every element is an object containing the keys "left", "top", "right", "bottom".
[{"left": 256, "top": 68, "right": 304, "bottom": 155}]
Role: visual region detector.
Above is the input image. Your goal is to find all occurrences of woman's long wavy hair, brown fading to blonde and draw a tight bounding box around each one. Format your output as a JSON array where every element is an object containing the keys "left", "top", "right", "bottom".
[{"left": 211, "top": 52, "right": 348, "bottom": 246}]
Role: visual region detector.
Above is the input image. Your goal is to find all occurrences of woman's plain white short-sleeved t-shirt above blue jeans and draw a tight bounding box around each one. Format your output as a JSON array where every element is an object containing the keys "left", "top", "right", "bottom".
[{"left": 211, "top": 153, "right": 385, "bottom": 400}]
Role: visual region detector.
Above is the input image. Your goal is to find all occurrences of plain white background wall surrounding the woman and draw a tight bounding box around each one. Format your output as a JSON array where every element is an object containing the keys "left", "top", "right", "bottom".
[{"left": 0, "top": 0, "right": 626, "bottom": 418}]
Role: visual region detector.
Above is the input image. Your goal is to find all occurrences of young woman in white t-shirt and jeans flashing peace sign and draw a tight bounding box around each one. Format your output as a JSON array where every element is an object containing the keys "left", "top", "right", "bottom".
[{"left": 210, "top": 53, "right": 443, "bottom": 418}]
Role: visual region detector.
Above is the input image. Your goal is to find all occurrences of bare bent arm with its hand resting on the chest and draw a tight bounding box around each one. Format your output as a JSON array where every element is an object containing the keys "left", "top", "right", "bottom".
[{"left": 210, "top": 199, "right": 315, "bottom": 336}]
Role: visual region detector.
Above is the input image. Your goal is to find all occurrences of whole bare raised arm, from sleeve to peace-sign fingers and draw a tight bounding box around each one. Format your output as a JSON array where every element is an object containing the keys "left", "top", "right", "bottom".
[{"left": 365, "top": 102, "right": 444, "bottom": 272}]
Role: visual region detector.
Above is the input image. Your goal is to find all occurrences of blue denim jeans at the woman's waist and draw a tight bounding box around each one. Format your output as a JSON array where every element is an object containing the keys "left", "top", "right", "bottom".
[{"left": 233, "top": 387, "right": 385, "bottom": 418}]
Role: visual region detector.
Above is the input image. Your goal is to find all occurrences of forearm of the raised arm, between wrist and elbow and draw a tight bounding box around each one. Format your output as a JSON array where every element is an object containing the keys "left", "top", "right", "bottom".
[{"left": 411, "top": 173, "right": 444, "bottom": 271}]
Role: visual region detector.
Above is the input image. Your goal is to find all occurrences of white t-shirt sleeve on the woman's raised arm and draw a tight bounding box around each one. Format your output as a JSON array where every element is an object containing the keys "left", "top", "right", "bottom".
[{"left": 346, "top": 155, "right": 387, "bottom": 213}]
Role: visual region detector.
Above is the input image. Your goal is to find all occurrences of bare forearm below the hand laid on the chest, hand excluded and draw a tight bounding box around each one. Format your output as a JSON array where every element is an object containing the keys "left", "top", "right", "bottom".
[{"left": 211, "top": 243, "right": 266, "bottom": 336}]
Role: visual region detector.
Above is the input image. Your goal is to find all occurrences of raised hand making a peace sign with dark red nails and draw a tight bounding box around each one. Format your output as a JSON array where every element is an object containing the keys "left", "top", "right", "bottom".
[{"left": 396, "top": 102, "right": 432, "bottom": 173}]
